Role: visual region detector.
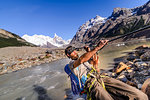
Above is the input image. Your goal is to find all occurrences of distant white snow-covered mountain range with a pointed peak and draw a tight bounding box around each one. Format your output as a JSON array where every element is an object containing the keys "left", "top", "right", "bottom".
[{"left": 22, "top": 33, "right": 71, "bottom": 47}]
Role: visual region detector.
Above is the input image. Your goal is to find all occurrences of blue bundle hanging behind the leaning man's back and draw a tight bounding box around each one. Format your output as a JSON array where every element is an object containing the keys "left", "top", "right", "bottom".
[{"left": 64, "top": 64, "right": 84, "bottom": 95}]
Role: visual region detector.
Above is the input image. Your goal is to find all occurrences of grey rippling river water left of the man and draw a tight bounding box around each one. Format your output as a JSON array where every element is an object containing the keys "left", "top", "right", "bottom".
[{"left": 0, "top": 59, "right": 69, "bottom": 100}]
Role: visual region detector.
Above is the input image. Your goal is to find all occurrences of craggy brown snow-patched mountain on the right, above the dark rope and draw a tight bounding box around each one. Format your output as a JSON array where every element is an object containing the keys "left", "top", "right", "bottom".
[{"left": 71, "top": 1, "right": 150, "bottom": 46}]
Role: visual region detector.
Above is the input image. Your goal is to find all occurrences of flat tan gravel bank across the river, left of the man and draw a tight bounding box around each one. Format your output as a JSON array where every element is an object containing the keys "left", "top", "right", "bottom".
[{"left": 0, "top": 46, "right": 66, "bottom": 74}]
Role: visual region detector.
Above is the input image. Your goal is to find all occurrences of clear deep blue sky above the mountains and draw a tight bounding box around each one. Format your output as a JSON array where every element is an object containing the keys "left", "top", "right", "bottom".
[{"left": 0, "top": 0, "right": 149, "bottom": 40}]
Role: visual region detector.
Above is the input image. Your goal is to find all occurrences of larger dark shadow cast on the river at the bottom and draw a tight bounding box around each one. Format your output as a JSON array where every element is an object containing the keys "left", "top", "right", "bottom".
[{"left": 33, "top": 85, "right": 52, "bottom": 100}]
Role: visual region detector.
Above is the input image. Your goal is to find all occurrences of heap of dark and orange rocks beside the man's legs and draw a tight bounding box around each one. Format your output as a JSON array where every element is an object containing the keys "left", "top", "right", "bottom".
[{"left": 102, "top": 45, "right": 150, "bottom": 99}]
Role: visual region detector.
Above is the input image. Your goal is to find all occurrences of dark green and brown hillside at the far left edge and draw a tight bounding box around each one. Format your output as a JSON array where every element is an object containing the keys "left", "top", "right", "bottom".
[{"left": 0, "top": 29, "right": 35, "bottom": 48}]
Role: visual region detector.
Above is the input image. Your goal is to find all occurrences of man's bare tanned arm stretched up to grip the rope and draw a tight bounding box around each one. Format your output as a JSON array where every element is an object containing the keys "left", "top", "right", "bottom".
[{"left": 73, "top": 40, "right": 108, "bottom": 68}]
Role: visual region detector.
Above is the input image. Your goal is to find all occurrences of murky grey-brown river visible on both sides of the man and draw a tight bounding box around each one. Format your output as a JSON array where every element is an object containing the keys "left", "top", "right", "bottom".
[{"left": 0, "top": 40, "right": 150, "bottom": 100}]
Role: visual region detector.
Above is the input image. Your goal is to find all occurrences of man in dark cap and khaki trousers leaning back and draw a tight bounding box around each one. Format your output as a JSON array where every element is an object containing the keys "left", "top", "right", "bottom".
[{"left": 65, "top": 40, "right": 148, "bottom": 100}]
